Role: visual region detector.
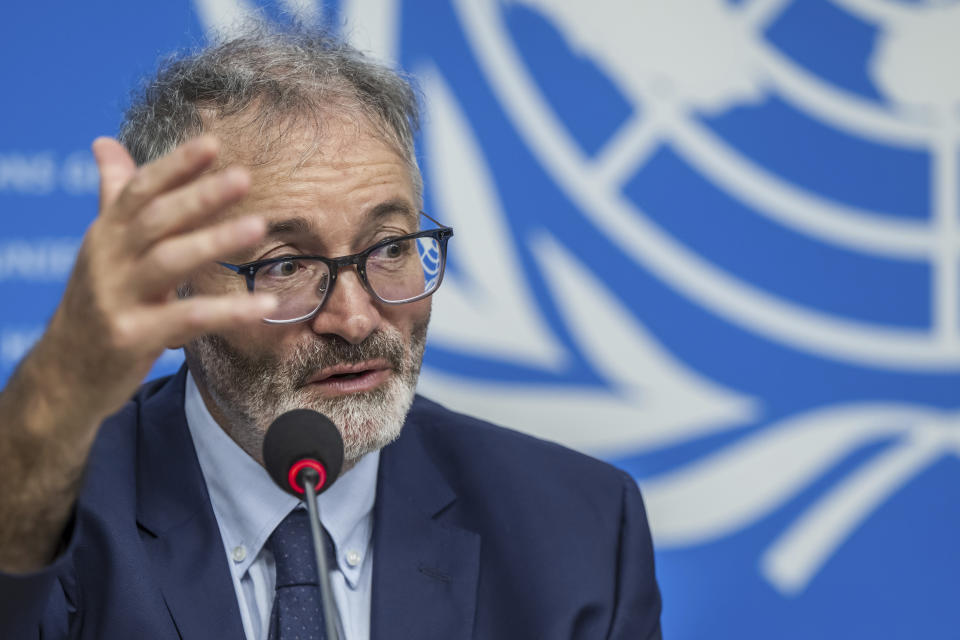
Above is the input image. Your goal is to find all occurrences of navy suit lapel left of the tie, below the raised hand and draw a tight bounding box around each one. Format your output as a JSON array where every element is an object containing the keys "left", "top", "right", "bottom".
[{"left": 137, "top": 368, "right": 244, "bottom": 640}]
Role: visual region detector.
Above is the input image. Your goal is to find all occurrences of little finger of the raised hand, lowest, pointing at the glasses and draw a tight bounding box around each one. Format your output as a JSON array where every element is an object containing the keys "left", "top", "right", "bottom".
[{"left": 129, "top": 293, "right": 277, "bottom": 349}]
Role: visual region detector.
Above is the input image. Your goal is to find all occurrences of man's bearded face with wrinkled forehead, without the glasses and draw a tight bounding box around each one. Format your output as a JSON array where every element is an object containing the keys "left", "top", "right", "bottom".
[{"left": 186, "top": 116, "right": 430, "bottom": 464}]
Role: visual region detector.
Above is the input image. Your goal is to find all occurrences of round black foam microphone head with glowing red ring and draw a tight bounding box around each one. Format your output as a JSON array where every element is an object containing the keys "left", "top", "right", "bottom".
[{"left": 263, "top": 409, "right": 343, "bottom": 498}]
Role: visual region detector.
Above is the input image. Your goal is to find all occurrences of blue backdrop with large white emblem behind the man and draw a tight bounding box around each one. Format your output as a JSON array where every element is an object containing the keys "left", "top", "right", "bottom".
[{"left": 0, "top": 0, "right": 960, "bottom": 640}]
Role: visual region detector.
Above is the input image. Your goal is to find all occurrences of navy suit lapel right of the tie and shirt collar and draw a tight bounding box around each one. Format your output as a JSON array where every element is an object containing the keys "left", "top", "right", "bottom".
[{"left": 370, "top": 410, "right": 480, "bottom": 640}]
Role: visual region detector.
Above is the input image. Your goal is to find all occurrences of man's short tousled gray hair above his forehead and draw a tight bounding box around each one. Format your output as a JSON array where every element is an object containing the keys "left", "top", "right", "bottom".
[{"left": 119, "top": 24, "right": 422, "bottom": 200}]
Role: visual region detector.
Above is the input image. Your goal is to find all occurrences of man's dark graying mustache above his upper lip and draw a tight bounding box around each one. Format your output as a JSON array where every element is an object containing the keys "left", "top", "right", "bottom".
[{"left": 290, "top": 330, "right": 404, "bottom": 389}]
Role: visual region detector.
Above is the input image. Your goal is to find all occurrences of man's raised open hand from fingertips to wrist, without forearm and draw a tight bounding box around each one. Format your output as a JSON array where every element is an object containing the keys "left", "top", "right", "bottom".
[{"left": 45, "top": 137, "right": 274, "bottom": 417}]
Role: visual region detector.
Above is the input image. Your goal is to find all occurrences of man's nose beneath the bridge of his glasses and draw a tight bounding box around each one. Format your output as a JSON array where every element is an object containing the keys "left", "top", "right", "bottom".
[{"left": 310, "top": 268, "right": 383, "bottom": 344}]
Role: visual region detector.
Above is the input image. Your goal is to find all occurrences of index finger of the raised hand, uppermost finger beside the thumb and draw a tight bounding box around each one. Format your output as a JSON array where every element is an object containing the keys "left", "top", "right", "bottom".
[{"left": 109, "top": 135, "right": 220, "bottom": 218}]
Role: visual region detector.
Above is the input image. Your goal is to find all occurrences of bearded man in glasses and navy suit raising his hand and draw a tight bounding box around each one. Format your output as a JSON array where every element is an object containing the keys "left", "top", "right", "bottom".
[{"left": 0, "top": 30, "right": 660, "bottom": 640}]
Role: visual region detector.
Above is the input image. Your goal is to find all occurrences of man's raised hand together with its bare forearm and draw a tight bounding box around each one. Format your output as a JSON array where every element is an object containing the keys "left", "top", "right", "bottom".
[{"left": 0, "top": 136, "right": 276, "bottom": 571}]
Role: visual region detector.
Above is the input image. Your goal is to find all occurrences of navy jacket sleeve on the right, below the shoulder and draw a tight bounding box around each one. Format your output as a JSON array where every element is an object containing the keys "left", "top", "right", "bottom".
[{"left": 608, "top": 474, "right": 662, "bottom": 640}]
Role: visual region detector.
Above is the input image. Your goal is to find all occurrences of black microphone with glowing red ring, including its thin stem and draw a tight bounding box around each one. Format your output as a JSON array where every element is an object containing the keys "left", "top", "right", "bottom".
[{"left": 263, "top": 409, "right": 343, "bottom": 640}]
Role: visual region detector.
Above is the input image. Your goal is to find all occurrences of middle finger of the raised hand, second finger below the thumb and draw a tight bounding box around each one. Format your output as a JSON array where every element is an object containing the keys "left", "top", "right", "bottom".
[{"left": 127, "top": 167, "right": 250, "bottom": 251}]
